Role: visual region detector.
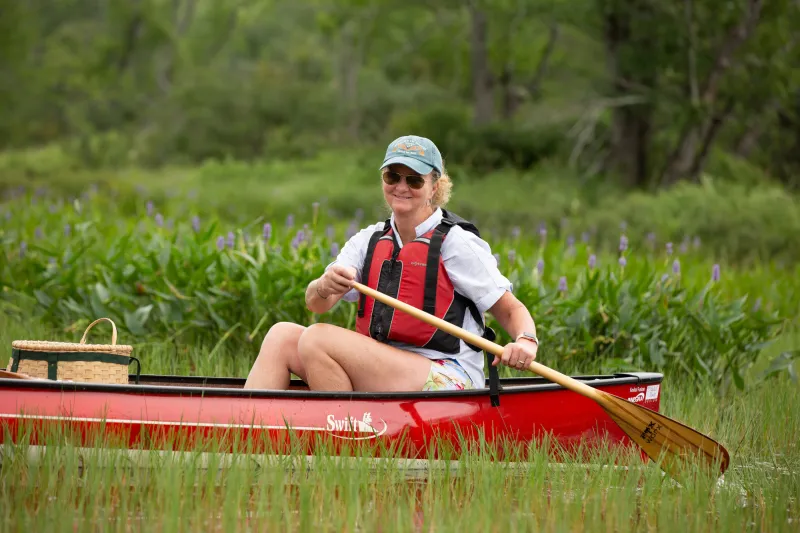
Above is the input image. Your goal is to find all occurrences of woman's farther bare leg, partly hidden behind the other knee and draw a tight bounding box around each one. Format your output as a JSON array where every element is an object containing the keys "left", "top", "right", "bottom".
[{"left": 244, "top": 322, "right": 306, "bottom": 390}]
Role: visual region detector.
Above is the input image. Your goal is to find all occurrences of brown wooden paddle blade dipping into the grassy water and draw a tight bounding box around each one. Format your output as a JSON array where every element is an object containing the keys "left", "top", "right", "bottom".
[{"left": 600, "top": 393, "right": 730, "bottom": 477}]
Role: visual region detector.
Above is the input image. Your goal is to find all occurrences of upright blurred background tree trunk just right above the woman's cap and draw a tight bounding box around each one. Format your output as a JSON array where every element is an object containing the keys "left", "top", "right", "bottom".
[{"left": 469, "top": 2, "right": 494, "bottom": 126}]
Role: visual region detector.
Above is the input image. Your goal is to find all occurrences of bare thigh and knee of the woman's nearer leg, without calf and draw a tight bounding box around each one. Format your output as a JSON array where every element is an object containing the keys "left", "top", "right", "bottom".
[{"left": 298, "top": 324, "right": 431, "bottom": 392}]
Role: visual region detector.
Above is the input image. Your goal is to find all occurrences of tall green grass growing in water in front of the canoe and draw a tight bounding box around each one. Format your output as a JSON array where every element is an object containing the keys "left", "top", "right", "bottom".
[{"left": 0, "top": 378, "right": 800, "bottom": 532}]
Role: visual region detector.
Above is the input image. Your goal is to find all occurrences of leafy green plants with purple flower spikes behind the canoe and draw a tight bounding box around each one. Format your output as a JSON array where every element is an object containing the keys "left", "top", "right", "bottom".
[{"left": 0, "top": 181, "right": 797, "bottom": 385}]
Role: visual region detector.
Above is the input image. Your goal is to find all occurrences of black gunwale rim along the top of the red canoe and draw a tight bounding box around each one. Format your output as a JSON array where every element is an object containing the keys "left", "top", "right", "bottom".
[{"left": 0, "top": 372, "right": 663, "bottom": 400}]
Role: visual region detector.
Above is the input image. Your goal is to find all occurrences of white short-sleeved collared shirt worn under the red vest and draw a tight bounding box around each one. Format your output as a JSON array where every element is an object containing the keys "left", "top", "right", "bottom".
[{"left": 326, "top": 208, "right": 513, "bottom": 388}]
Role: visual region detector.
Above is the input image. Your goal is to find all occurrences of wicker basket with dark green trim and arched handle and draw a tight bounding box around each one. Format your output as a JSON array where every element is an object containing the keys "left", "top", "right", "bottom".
[{"left": 9, "top": 318, "right": 141, "bottom": 384}]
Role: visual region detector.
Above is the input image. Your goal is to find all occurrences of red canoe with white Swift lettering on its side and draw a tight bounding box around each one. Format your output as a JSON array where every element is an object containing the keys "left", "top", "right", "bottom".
[{"left": 0, "top": 373, "right": 663, "bottom": 458}]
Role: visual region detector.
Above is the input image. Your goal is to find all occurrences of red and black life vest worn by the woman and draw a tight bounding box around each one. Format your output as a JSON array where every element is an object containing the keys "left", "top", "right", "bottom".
[{"left": 356, "top": 210, "right": 484, "bottom": 354}]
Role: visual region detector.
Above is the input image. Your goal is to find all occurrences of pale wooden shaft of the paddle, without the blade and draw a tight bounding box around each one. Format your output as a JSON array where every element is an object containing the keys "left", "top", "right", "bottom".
[{"left": 353, "top": 282, "right": 606, "bottom": 405}]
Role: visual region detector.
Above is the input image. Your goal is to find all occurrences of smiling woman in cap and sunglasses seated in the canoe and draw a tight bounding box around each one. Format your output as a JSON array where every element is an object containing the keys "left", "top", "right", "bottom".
[{"left": 245, "top": 136, "right": 539, "bottom": 392}]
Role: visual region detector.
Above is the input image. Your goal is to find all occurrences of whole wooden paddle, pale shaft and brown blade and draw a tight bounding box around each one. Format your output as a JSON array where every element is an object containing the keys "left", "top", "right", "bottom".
[{"left": 353, "top": 282, "right": 730, "bottom": 476}]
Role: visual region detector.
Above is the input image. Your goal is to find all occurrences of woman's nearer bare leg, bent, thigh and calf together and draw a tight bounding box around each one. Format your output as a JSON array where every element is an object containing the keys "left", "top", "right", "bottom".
[{"left": 298, "top": 324, "right": 431, "bottom": 392}]
